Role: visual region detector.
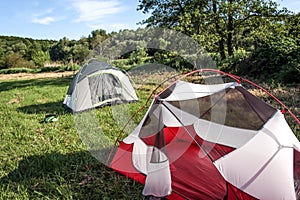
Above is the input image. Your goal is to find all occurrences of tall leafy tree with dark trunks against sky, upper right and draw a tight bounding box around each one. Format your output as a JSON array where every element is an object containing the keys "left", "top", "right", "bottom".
[{"left": 137, "top": 0, "right": 281, "bottom": 59}]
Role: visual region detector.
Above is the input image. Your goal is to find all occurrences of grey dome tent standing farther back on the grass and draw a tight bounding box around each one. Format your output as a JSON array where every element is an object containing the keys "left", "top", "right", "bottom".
[{"left": 63, "top": 61, "right": 138, "bottom": 112}]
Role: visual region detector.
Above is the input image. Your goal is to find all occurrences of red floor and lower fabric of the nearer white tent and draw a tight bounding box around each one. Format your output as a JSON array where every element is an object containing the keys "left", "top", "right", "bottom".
[{"left": 111, "top": 126, "right": 255, "bottom": 200}]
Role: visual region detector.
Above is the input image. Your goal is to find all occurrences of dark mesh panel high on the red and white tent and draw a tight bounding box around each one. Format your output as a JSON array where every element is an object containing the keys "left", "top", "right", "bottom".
[{"left": 169, "top": 88, "right": 276, "bottom": 130}]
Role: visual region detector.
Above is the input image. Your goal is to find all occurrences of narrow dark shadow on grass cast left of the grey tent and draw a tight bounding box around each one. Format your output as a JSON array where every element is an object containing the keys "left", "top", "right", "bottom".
[{"left": 17, "top": 101, "right": 70, "bottom": 115}]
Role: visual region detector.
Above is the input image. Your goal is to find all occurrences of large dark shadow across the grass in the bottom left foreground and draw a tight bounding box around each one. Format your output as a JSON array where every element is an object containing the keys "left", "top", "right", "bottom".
[{"left": 0, "top": 151, "right": 144, "bottom": 199}]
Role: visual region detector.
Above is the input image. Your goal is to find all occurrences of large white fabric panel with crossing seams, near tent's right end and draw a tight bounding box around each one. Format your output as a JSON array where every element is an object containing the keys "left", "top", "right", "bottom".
[{"left": 214, "top": 111, "right": 300, "bottom": 200}]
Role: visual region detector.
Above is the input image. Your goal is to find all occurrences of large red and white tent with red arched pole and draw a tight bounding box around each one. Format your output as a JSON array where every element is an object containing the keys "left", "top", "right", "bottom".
[{"left": 110, "top": 69, "right": 300, "bottom": 200}]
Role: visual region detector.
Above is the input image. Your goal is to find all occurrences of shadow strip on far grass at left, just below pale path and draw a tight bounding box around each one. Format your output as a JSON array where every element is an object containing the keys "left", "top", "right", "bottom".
[{"left": 0, "top": 76, "right": 73, "bottom": 91}]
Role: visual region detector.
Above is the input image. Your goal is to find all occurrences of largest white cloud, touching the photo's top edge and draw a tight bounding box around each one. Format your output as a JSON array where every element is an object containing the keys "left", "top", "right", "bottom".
[{"left": 71, "top": 0, "right": 126, "bottom": 23}]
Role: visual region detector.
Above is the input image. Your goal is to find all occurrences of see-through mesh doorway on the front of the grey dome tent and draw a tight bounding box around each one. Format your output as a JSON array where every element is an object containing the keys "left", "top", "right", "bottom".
[{"left": 88, "top": 73, "right": 122, "bottom": 104}]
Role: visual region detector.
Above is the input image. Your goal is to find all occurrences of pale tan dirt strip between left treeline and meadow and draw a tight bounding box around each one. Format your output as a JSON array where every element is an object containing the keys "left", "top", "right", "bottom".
[{"left": 0, "top": 71, "right": 76, "bottom": 80}]
